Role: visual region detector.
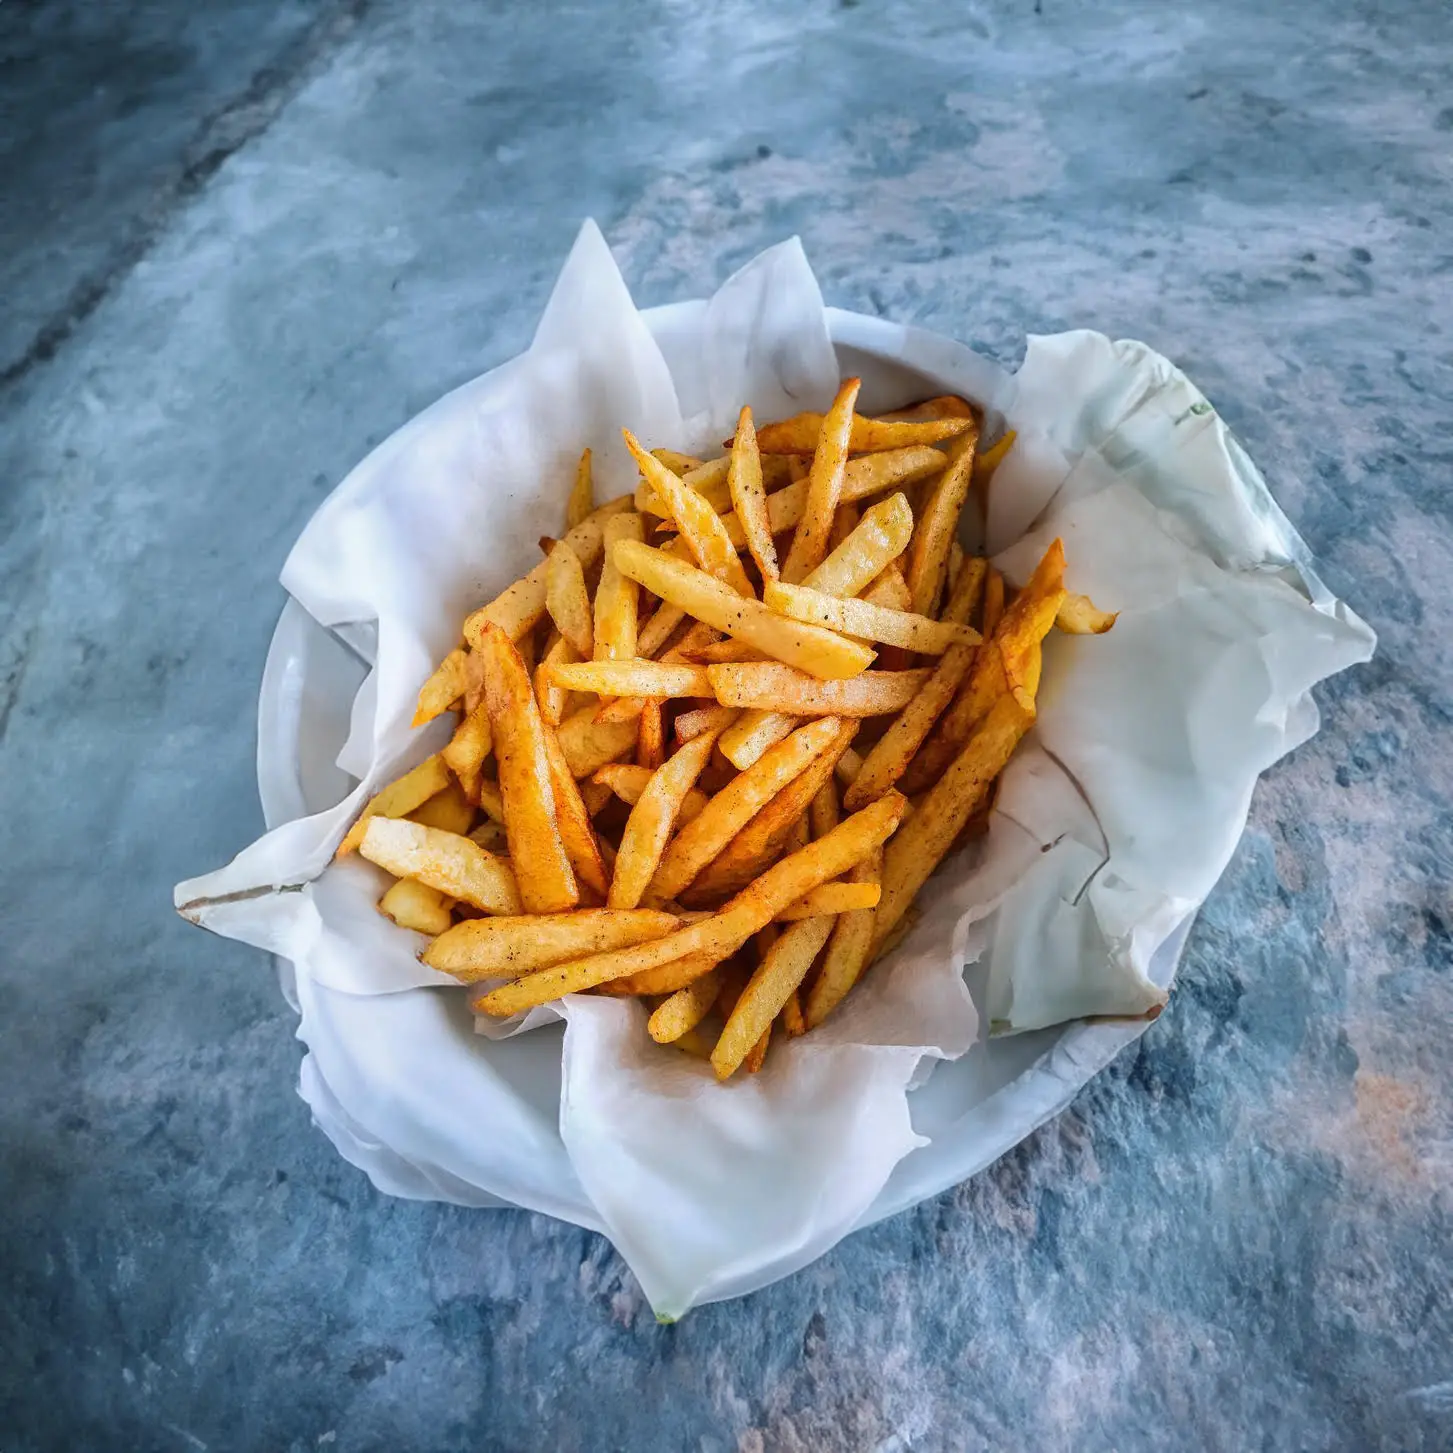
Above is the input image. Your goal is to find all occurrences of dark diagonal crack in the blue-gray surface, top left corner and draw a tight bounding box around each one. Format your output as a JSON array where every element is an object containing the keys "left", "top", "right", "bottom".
[{"left": 0, "top": 0, "right": 373, "bottom": 389}]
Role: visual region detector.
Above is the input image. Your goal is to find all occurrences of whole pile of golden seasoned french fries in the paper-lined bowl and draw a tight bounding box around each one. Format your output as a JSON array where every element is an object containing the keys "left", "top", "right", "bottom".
[{"left": 339, "top": 379, "right": 1114, "bottom": 1080}]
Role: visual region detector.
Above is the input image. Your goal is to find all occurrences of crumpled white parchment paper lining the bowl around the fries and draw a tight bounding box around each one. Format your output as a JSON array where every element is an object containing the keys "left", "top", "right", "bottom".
[{"left": 176, "top": 224, "right": 1372, "bottom": 1315}]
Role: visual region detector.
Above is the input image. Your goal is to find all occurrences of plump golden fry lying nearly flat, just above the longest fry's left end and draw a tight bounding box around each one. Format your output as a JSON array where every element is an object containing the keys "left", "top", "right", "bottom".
[{"left": 420, "top": 908, "right": 681, "bottom": 984}]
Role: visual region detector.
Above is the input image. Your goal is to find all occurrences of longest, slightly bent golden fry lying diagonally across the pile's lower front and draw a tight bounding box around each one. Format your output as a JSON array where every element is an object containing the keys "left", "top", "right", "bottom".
[{"left": 475, "top": 793, "right": 905, "bottom": 1019}]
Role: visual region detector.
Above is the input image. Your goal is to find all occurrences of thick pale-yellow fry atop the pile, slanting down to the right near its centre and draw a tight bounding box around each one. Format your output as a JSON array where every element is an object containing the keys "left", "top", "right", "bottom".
[{"left": 607, "top": 539, "right": 873, "bottom": 679}]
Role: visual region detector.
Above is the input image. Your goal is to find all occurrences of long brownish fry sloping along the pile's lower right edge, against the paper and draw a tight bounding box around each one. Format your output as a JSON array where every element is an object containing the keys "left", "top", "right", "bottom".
[{"left": 873, "top": 693, "right": 1035, "bottom": 947}]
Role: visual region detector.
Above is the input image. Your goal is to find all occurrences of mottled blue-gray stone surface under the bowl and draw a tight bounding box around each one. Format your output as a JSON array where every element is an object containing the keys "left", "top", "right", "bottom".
[{"left": 0, "top": 0, "right": 1453, "bottom": 1453}]
